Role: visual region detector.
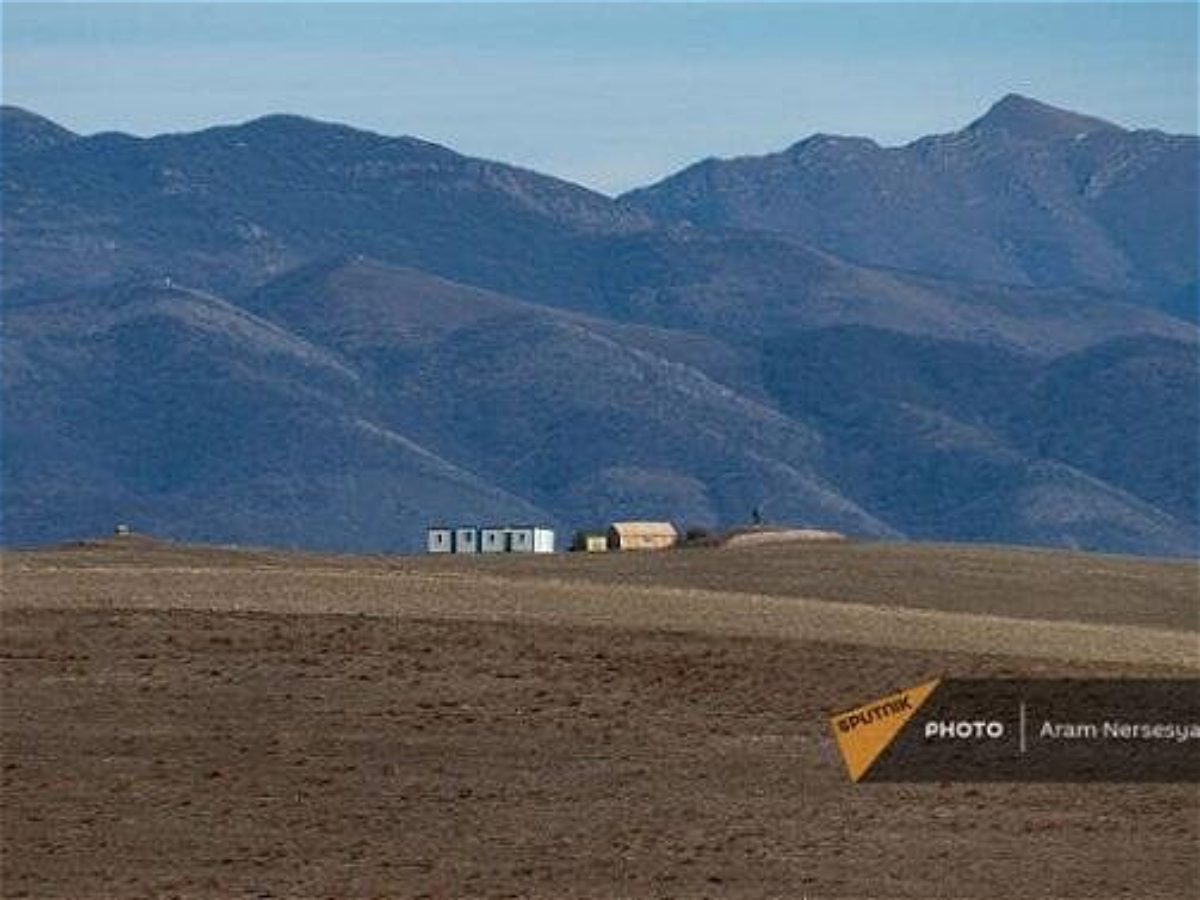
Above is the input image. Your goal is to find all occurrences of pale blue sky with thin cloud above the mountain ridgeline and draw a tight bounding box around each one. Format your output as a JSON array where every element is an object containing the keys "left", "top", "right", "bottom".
[{"left": 0, "top": 1, "right": 1198, "bottom": 193}]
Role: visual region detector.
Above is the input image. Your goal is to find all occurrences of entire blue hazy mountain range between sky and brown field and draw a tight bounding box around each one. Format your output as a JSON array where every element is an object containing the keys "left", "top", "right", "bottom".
[{"left": 0, "top": 96, "right": 1200, "bottom": 556}]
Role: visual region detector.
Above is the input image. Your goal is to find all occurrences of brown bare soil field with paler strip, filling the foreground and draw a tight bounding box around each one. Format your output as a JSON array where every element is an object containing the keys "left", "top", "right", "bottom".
[{"left": 0, "top": 538, "right": 1200, "bottom": 898}]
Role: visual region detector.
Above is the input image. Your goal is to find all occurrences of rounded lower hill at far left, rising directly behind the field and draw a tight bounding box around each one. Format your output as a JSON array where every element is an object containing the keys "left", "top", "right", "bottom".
[{"left": 0, "top": 283, "right": 547, "bottom": 550}]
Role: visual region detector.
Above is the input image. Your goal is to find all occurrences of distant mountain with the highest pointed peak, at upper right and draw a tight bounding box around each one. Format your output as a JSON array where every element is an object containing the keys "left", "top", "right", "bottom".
[{"left": 624, "top": 95, "right": 1200, "bottom": 318}]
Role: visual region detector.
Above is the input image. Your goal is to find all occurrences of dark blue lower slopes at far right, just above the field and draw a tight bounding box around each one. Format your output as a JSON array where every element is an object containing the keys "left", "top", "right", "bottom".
[{"left": 763, "top": 328, "right": 1200, "bottom": 554}]
